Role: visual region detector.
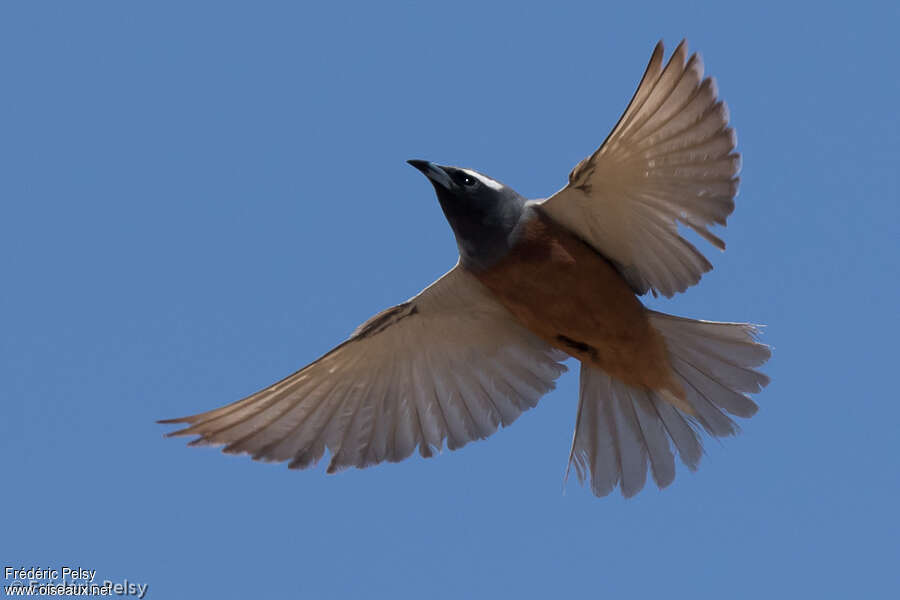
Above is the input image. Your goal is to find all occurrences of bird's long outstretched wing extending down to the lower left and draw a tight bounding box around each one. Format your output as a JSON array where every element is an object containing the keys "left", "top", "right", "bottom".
[{"left": 163, "top": 265, "right": 566, "bottom": 472}]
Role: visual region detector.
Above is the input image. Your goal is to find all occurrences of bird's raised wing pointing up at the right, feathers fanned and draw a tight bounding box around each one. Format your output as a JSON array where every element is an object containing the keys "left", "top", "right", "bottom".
[{"left": 541, "top": 41, "right": 740, "bottom": 297}]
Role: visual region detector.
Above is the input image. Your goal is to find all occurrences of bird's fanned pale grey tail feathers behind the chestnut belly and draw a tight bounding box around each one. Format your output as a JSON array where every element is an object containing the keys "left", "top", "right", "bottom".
[{"left": 566, "top": 311, "right": 771, "bottom": 497}]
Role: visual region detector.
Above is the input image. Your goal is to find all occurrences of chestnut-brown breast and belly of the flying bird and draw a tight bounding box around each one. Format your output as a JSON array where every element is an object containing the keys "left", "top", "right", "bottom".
[{"left": 474, "top": 208, "right": 684, "bottom": 396}]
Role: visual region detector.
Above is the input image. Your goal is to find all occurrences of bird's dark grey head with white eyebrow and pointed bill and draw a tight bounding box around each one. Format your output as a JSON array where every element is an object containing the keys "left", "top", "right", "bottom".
[{"left": 407, "top": 160, "right": 526, "bottom": 269}]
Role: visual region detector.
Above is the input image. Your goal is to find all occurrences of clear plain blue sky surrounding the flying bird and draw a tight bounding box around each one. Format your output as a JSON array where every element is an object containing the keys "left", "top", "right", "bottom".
[{"left": 0, "top": 1, "right": 900, "bottom": 599}]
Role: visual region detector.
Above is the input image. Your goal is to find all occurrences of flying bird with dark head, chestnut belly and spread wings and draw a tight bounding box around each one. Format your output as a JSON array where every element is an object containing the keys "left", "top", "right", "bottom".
[{"left": 160, "top": 40, "right": 771, "bottom": 498}]
